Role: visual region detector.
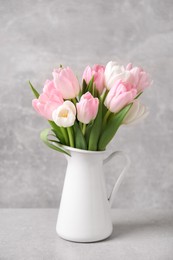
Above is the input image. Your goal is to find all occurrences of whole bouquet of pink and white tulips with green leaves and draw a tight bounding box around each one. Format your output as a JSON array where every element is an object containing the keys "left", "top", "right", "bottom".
[{"left": 30, "top": 61, "right": 151, "bottom": 154}]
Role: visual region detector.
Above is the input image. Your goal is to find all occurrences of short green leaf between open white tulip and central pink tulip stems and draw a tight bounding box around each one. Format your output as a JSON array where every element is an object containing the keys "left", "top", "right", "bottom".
[{"left": 73, "top": 122, "right": 87, "bottom": 150}]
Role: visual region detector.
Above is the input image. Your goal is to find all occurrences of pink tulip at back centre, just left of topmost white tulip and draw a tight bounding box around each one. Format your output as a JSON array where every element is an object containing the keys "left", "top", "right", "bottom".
[{"left": 82, "top": 64, "right": 105, "bottom": 94}]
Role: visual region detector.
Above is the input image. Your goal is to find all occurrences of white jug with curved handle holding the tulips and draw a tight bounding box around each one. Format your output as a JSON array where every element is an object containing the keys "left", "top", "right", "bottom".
[{"left": 56, "top": 147, "right": 130, "bottom": 242}]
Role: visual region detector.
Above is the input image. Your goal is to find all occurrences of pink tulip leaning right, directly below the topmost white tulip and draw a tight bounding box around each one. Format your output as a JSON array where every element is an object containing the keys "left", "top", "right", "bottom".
[{"left": 104, "top": 80, "right": 137, "bottom": 113}]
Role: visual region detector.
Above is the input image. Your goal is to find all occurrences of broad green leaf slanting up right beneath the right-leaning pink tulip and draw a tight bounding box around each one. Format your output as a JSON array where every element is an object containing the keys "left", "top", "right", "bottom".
[{"left": 98, "top": 104, "right": 132, "bottom": 151}]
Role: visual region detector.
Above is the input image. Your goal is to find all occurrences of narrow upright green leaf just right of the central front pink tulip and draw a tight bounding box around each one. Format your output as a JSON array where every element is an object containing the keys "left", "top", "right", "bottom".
[{"left": 88, "top": 97, "right": 102, "bottom": 151}]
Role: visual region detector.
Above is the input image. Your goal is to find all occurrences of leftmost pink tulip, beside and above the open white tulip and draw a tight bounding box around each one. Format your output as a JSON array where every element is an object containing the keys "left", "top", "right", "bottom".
[{"left": 32, "top": 80, "right": 64, "bottom": 120}]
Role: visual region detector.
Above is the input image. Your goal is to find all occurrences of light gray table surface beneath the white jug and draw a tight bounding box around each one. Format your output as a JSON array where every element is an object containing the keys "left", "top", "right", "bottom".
[{"left": 0, "top": 209, "right": 173, "bottom": 260}]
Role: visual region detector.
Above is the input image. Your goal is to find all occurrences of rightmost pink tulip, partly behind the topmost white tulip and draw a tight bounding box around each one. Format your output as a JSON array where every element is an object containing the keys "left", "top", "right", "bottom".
[{"left": 126, "top": 63, "right": 151, "bottom": 93}]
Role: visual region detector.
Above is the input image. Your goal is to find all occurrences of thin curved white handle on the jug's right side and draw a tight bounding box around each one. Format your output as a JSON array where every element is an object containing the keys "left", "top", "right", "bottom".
[{"left": 103, "top": 151, "right": 131, "bottom": 206}]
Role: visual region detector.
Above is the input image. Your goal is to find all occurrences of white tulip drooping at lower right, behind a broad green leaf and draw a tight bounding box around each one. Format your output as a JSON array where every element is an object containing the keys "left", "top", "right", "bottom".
[{"left": 123, "top": 99, "right": 149, "bottom": 125}]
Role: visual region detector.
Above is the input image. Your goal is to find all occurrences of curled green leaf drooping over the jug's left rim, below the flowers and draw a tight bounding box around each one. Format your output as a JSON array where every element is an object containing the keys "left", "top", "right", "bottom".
[{"left": 40, "top": 128, "right": 71, "bottom": 156}]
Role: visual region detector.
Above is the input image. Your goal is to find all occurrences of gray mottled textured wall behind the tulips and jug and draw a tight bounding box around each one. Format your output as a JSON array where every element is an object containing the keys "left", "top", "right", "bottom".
[{"left": 0, "top": 0, "right": 173, "bottom": 208}]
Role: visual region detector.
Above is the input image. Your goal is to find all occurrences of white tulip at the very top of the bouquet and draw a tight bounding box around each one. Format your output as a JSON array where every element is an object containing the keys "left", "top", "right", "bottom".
[{"left": 104, "top": 61, "right": 130, "bottom": 90}]
